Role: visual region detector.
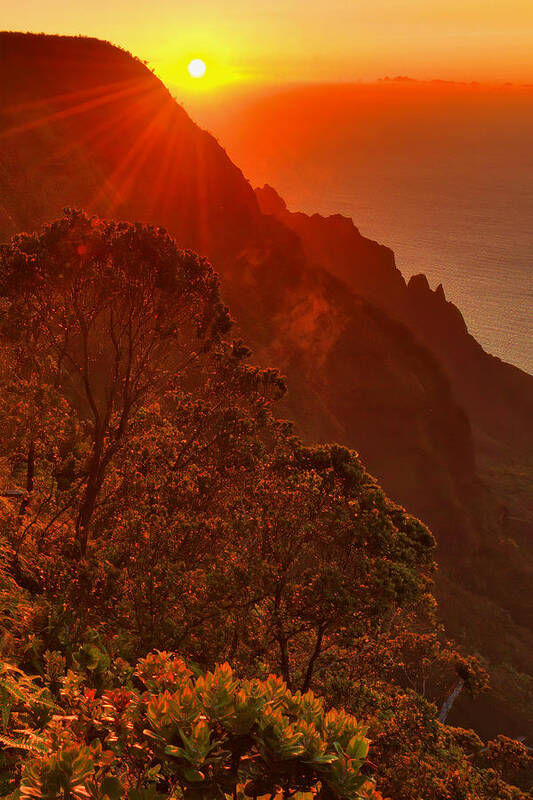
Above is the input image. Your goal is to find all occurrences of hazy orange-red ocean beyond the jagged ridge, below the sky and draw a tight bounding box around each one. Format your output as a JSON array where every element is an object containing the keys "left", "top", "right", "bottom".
[{"left": 188, "top": 85, "right": 533, "bottom": 373}]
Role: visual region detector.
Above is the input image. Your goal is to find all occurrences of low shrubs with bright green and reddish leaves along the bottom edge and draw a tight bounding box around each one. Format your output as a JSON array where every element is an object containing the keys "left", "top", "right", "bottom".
[{"left": 1, "top": 652, "right": 380, "bottom": 800}]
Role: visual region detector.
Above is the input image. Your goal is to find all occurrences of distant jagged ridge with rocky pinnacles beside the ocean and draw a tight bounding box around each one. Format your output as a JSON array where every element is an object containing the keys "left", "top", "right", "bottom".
[{"left": 256, "top": 186, "right": 533, "bottom": 451}]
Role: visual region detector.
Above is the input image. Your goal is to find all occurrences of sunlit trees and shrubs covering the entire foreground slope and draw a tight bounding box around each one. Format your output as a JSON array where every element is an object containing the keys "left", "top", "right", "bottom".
[{"left": 0, "top": 212, "right": 530, "bottom": 800}]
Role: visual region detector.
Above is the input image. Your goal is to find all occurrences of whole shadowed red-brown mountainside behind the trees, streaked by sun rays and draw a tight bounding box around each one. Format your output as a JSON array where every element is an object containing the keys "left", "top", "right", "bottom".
[{"left": 0, "top": 34, "right": 533, "bottom": 733}]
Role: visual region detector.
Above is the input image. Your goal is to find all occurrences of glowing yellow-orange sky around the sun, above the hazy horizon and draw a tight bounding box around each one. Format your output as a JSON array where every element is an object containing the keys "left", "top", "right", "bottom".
[{"left": 4, "top": 0, "right": 533, "bottom": 94}]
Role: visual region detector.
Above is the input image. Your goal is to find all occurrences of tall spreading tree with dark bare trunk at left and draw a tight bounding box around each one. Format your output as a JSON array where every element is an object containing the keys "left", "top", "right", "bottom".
[{"left": 0, "top": 211, "right": 281, "bottom": 558}]
